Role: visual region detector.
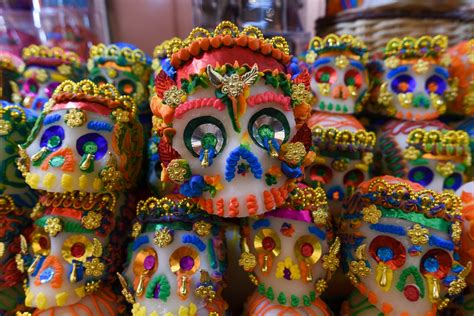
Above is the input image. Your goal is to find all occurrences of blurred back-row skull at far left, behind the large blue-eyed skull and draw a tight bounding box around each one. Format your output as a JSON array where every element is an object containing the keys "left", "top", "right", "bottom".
[{"left": 20, "top": 45, "right": 83, "bottom": 113}]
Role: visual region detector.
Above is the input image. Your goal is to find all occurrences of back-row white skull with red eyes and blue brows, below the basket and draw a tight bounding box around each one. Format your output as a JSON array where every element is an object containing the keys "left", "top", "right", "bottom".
[{"left": 303, "top": 34, "right": 369, "bottom": 113}]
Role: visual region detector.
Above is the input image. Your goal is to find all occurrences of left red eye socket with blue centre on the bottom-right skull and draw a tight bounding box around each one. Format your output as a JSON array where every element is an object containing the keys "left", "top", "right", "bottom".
[{"left": 369, "top": 235, "right": 406, "bottom": 270}]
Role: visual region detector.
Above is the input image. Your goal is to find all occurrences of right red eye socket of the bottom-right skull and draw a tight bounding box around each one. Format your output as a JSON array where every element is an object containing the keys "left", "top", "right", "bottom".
[{"left": 420, "top": 248, "right": 453, "bottom": 279}]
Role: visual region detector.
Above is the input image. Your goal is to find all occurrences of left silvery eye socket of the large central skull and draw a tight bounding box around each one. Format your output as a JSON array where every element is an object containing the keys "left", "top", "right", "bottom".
[{"left": 183, "top": 116, "right": 226, "bottom": 157}]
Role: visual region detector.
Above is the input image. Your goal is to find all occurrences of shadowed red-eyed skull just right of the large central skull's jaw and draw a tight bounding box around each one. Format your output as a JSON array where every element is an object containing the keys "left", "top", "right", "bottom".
[{"left": 305, "top": 112, "right": 376, "bottom": 212}]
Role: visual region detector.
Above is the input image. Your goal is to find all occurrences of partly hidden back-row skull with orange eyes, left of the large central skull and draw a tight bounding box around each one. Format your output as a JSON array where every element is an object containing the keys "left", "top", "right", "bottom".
[{"left": 87, "top": 43, "right": 152, "bottom": 114}]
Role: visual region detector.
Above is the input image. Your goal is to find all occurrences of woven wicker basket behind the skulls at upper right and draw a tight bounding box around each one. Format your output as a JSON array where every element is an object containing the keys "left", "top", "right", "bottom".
[{"left": 316, "top": 10, "right": 474, "bottom": 56}]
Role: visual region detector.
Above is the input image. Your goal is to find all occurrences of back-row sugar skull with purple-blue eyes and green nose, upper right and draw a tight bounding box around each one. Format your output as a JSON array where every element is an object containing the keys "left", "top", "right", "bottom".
[{"left": 370, "top": 35, "right": 457, "bottom": 121}]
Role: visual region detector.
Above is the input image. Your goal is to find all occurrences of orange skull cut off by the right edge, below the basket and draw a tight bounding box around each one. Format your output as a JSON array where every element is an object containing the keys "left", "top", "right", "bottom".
[{"left": 449, "top": 39, "right": 474, "bottom": 116}]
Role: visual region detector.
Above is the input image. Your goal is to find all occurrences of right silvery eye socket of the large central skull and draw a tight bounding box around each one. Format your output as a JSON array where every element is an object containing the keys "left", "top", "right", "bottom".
[{"left": 248, "top": 108, "right": 290, "bottom": 149}]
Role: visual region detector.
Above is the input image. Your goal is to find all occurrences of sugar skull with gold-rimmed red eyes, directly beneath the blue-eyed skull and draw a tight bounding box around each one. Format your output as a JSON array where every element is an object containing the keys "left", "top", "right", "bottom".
[{"left": 16, "top": 191, "right": 123, "bottom": 310}]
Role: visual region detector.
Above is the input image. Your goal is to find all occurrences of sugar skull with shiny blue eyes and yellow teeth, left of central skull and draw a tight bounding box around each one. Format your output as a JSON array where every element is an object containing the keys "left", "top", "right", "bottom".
[{"left": 17, "top": 80, "right": 143, "bottom": 192}]
